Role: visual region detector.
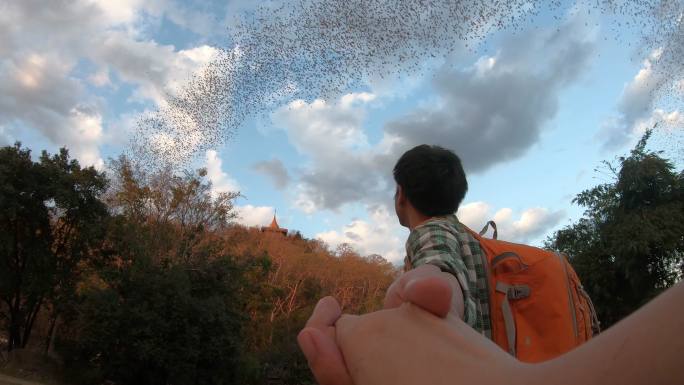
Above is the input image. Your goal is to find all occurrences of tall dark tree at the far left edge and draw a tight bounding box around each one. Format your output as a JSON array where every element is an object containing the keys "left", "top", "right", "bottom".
[{"left": 0, "top": 143, "right": 107, "bottom": 350}]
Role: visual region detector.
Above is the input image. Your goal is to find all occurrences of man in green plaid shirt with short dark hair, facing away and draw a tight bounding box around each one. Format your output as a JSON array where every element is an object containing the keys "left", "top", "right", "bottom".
[{"left": 385, "top": 144, "right": 491, "bottom": 337}]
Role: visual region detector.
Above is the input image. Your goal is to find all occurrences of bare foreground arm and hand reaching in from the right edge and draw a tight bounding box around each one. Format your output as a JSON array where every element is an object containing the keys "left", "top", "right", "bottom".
[{"left": 332, "top": 283, "right": 684, "bottom": 385}]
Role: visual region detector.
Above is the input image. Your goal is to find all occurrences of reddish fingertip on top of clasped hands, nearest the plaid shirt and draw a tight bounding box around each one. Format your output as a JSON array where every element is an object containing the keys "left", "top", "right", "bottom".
[{"left": 404, "top": 276, "right": 453, "bottom": 318}]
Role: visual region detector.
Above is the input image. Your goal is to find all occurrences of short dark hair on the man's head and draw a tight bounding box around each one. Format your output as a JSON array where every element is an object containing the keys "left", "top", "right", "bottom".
[{"left": 393, "top": 144, "right": 468, "bottom": 216}]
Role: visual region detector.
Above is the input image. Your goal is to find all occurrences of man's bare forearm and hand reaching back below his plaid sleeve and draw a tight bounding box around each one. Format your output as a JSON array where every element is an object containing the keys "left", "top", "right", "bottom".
[{"left": 384, "top": 265, "right": 464, "bottom": 319}]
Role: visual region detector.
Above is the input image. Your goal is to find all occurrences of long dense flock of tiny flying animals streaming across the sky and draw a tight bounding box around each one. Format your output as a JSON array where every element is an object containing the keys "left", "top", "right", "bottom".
[{"left": 131, "top": 0, "right": 684, "bottom": 167}]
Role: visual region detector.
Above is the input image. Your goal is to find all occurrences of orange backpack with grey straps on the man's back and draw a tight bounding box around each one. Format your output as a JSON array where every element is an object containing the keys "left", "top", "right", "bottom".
[{"left": 468, "top": 221, "right": 599, "bottom": 362}]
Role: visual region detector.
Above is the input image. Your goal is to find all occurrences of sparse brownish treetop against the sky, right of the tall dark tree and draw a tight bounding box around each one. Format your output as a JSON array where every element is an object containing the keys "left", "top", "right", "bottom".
[{"left": 106, "top": 156, "right": 240, "bottom": 261}]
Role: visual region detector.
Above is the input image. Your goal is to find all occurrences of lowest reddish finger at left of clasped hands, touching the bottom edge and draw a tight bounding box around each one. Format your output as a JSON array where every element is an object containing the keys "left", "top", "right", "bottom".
[{"left": 297, "top": 327, "right": 353, "bottom": 385}]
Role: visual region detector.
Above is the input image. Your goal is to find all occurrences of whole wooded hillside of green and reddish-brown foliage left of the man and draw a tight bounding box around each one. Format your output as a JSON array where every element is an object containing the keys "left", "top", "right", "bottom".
[{"left": 0, "top": 145, "right": 396, "bottom": 384}]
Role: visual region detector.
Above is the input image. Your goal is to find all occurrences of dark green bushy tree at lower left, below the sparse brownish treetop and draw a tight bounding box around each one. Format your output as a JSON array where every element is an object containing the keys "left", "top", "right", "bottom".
[{"left": 61, "top": 252, "right": 251, "bottom": 384}]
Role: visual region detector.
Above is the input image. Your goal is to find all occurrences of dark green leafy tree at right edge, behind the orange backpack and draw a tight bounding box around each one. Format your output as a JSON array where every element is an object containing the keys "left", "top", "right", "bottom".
[{"left": 547, "top": 131, "right": 684, "bottom": 327}]
